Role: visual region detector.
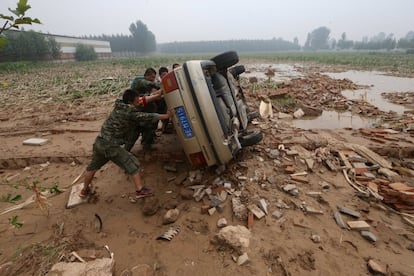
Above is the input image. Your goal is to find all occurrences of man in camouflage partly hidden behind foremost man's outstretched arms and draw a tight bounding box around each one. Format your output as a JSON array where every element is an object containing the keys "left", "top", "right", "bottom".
[{"left": 129, "top": 68, "right": 167, "bottom": 151}]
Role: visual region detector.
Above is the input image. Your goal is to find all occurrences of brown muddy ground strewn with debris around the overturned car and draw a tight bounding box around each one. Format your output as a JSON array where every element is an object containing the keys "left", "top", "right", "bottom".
[{"left": 0, "top": 61, "right": 414, "bottom": 275}]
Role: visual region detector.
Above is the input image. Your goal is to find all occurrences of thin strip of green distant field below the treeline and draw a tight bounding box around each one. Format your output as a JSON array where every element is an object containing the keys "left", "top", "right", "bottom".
[{"left": 0, "top": 52, "right": 414, "bottom": 75}]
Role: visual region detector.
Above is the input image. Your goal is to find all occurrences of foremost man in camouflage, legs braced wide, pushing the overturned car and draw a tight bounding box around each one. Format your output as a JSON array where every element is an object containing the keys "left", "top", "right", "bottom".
[{"left": 79, "top": 89, "right": 173, "bottom": 198}]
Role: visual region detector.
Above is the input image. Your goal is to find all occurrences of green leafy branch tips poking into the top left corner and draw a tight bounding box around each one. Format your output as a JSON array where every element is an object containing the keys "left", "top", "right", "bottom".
[{"left": 0, "top": 0, "right": 42, "bottom": 49}]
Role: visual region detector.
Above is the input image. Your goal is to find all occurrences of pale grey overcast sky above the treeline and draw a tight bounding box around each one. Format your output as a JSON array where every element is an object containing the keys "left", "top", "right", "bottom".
[{"left": 0, "top": 0, "right": 414, "bottom": 45}]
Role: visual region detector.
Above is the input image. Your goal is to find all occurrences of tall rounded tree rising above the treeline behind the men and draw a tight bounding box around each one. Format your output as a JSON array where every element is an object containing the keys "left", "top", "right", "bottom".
[{"left": 129, "top": 20, "right": 156, "bottom": 54}]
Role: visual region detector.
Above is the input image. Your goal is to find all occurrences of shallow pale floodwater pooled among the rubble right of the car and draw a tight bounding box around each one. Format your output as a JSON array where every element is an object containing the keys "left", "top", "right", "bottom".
[{"left": 244, "top": 64, "right": 414, "bottom": 129}]
